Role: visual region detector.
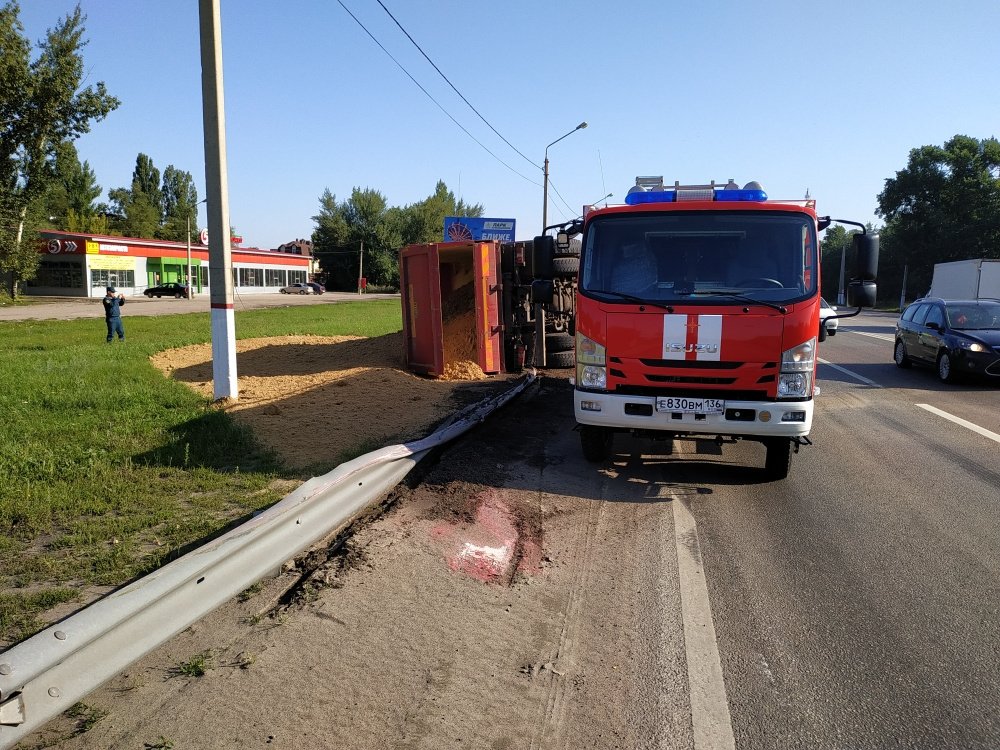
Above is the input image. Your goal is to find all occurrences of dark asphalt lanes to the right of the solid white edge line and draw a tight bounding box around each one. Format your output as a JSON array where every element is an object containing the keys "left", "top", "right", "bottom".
[{"left": 687, "top": 315, "right": 1000, "bottom": 748}]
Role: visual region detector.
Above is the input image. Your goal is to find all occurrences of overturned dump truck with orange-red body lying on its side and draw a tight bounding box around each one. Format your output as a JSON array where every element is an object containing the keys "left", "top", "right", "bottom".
[{"left": 399, "top": 241, "right": 580, "bottom": 379}]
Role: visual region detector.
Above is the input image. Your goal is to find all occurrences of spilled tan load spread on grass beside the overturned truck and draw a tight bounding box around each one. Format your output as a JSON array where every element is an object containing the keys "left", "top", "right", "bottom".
[{"left": 152, "top": 332, "right": 510, "bottom": 468}]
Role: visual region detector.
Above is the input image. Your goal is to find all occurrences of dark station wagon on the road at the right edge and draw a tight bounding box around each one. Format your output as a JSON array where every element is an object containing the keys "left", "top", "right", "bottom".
[{"left": 893, "top": 297, "right": 1000, "bottom": 383}]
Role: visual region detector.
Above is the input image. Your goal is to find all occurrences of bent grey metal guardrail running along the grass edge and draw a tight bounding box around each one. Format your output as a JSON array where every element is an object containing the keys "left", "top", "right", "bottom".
[{"left": 0, "top": 371, "right": 535, "bottom": 748}]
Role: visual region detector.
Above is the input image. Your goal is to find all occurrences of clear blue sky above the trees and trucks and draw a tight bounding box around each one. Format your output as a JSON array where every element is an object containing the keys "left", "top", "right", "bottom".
[{"left": 21, "top": 0, "right": 1000, "bottom": 248}]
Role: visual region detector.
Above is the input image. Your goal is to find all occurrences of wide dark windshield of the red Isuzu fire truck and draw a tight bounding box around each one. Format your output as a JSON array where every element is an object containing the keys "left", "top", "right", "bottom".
[{"left": 579, "top": 211, "right": 817, "bottom": 305}]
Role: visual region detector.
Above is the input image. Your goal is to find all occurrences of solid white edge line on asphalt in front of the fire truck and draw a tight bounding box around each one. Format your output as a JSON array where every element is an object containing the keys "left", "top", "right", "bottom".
[{"left": 671, "top": 495, "right": 736, "bottom": 750}]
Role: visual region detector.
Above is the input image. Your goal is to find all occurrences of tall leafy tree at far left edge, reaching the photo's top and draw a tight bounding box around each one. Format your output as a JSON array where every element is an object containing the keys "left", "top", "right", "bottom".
[{"left": 0, "top": 0, "right": 119, "bottom": 296}]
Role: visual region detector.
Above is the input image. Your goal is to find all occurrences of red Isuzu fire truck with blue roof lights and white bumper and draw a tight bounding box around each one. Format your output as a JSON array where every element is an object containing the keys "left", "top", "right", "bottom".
[{"left": 535, "top": 177, "right": 878, "bottom": 480}]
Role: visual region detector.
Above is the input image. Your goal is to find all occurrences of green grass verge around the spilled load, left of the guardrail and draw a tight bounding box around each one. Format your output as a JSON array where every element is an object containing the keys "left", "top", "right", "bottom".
[{"left": 0, "top": 300, "right": 401, "bottom": 641}]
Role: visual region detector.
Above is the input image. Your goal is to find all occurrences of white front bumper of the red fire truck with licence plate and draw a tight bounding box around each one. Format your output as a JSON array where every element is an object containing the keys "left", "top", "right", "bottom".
[{"left": 573, "top": 390, "right": 813, "bottom": 437}]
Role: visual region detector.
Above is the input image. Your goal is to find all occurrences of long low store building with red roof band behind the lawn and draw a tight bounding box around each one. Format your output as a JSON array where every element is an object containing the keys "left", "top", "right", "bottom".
[{"left": 25, "top": 230, "right": 315, "bottom": 297}]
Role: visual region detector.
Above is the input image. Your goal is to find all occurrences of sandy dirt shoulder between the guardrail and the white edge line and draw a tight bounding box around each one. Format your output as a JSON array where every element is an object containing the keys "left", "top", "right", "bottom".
[{"left": 31, "top": 379, "right": 691, "bottom": 750}]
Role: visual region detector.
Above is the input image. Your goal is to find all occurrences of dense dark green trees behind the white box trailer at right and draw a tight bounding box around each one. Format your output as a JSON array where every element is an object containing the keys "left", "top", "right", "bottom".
[{"left": 878, "top": 135, "right": 1000, "bottom": 302}]
